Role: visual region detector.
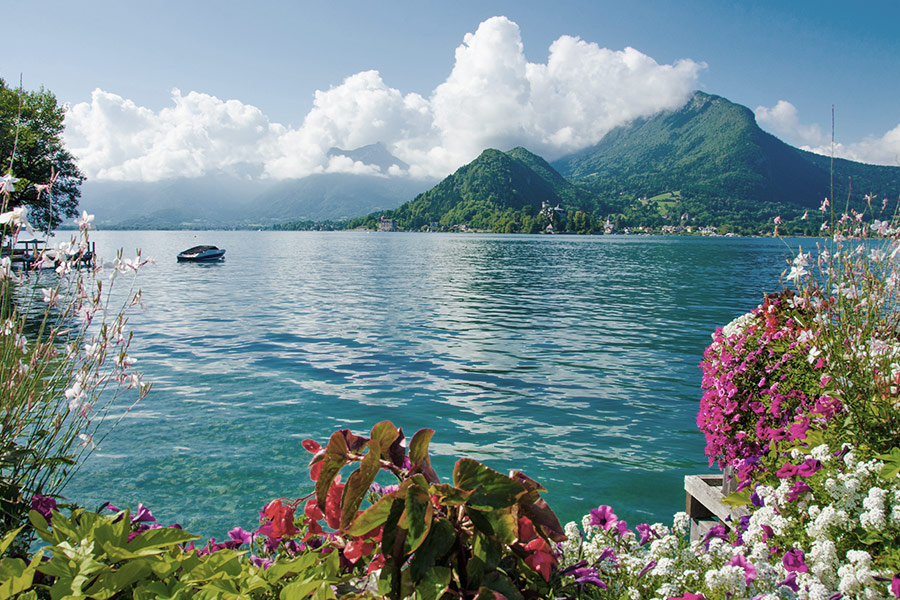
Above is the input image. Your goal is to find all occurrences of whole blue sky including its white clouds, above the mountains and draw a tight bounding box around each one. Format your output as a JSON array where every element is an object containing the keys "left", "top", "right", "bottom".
[{"left": 0, "top": 0, "right": 900, "bottom": 180}]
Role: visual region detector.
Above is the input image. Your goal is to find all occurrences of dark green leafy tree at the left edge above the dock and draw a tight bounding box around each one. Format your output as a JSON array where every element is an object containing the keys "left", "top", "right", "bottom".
[{"left": 0, "top": 78, "right": 85, "bottom": 230}]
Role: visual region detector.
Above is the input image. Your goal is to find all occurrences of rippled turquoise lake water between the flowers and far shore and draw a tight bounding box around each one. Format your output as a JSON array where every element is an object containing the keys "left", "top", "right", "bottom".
[{"left": 66, "top": 231, "right": 788, "bottom": 539}]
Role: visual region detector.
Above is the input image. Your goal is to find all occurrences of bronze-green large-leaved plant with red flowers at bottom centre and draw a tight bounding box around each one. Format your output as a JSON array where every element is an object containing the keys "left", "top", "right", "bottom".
[{"left": 304, "top": 421, "right": 565, "bottom": 599}]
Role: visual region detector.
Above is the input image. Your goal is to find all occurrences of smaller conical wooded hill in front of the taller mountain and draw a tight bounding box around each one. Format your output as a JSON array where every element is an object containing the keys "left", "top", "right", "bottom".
[{"left": 351, "top": 148, "right": 600, "bottom": 231}]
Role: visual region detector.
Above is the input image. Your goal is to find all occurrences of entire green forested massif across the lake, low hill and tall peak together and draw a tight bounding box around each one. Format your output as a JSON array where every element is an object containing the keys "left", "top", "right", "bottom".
[{"left": 350, "top": 92, "right": 900, "bottom": 233}]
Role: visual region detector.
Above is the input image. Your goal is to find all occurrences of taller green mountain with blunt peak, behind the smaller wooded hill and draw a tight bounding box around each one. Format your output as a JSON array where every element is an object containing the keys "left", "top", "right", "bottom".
[{"left": 553, "top": 92, "right": 900, "bottom": 223}]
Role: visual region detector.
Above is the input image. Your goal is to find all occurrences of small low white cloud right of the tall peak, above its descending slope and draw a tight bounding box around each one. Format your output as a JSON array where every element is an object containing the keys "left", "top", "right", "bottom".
[{"left": 756, "top": 100, "right": 900, "bottom": 166}]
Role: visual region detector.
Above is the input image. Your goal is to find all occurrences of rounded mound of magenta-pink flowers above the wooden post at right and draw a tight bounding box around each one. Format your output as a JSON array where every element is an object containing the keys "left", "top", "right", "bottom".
[{"left": 697, "top": 291, "right": 843, "bottom": 484}]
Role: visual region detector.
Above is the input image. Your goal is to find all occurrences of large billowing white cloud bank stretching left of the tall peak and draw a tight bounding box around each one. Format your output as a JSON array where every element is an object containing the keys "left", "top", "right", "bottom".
[{"left": 66, "top": 17, "right": 708, "bottom": 181}]
